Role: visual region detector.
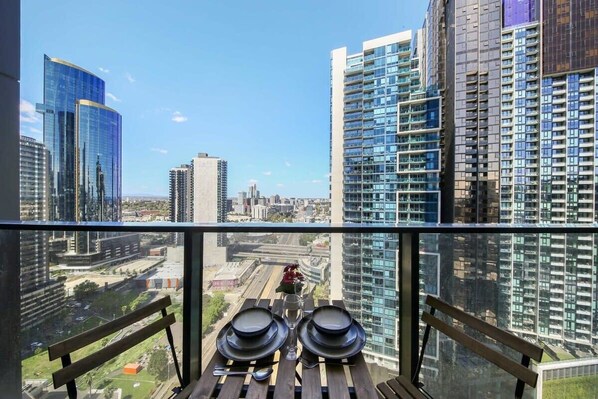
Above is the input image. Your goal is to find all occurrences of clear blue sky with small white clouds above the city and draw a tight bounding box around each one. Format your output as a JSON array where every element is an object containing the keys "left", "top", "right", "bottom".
[{"left": 21, "top": 0, "right": 427, "bottom": 197}]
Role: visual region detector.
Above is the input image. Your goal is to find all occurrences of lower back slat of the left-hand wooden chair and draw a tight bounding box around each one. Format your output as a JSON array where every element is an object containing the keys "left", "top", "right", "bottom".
[{"left": 52, "top": 314, "right": 176, "bottom": 388}]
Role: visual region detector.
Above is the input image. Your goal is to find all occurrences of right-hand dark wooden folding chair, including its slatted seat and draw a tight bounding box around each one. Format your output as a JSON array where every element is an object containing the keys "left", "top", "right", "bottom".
[{"left": 376, "top": 295, "right": 543, "bottom": 399}]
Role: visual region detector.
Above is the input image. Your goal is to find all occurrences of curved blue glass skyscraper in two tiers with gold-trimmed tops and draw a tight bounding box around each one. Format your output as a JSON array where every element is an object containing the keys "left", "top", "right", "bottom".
[{"left": 37, "top": 56, "right": 128, "bottom": 263}]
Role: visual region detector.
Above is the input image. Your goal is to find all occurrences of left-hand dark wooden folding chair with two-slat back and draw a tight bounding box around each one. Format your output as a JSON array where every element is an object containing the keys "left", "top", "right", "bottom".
[{"left": 48, "top": 296, "right": 190, "bottom": 399}]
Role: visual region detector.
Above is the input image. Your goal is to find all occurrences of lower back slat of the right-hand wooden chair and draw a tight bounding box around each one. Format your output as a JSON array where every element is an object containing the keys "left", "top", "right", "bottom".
[{"left": 422, "top": 312, "right": 538, "bottom": 387}]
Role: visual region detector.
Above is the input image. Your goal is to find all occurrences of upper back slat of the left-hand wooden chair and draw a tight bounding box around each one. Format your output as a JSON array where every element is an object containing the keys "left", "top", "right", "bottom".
[{"left": 48, "top": 296, "right": 171, "bottom": 361}]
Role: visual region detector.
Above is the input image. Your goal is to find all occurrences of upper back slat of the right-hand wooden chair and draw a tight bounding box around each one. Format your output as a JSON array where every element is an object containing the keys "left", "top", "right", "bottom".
[{"left": 426, "top": 295, "right": 544, "bottom": 362}]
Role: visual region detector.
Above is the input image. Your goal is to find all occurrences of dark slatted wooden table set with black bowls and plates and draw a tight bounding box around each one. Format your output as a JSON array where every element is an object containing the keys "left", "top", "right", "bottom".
[{"left": 190, "top": 299, "right": 378, "bottom": 399}]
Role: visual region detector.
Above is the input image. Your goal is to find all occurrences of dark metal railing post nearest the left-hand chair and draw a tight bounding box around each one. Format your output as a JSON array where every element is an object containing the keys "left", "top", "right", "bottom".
[{"left": 183, "top": 231, "right": 204, "bottom": 386}]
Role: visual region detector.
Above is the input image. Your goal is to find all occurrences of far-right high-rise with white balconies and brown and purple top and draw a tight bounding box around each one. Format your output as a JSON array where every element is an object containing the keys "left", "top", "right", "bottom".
[{"left": 499, "top": 0, "right": 598, "bottom": 349}]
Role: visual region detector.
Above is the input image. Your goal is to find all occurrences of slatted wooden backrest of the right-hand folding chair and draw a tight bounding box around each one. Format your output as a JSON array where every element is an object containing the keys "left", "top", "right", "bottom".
[{"left": 417, "top": 295, "right": 544, "bottom": 398}]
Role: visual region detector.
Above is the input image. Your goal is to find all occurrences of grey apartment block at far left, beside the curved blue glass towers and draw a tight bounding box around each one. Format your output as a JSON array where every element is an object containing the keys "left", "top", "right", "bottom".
[{"left": 19, "top": 136, "right": 64, "bottom": 328}]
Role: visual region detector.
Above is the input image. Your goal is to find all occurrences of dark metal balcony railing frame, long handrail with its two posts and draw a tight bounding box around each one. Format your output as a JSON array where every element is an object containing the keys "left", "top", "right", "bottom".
[{"left": 0, "top": 220, "right": 598, "bottom": 394}]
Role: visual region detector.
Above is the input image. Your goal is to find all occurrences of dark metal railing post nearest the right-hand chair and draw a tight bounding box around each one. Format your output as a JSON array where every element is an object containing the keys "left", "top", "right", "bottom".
[{"left": 398, "top": 233, "right": 419, "bottom": 381}]
